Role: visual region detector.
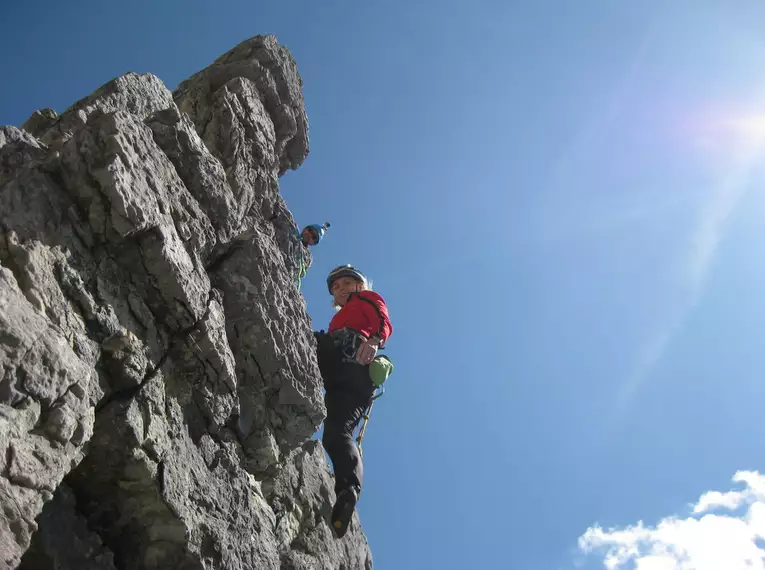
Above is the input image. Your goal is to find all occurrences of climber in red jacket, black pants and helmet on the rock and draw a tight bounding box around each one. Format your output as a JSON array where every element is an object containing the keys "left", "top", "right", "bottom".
[{"left": 314, "top": 265, "right": 393, "bottom": 538}]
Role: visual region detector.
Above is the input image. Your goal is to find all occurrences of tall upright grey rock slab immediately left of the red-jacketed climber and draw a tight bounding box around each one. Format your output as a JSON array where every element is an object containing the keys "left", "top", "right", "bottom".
[{"left": 212, "top": 224, "right": 325, "bottom": 473}]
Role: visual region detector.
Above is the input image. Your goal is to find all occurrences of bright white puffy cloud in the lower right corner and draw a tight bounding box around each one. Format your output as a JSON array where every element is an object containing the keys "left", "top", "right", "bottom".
[{"left": 579, "top": 471, "right": 765, "bottom": 570}]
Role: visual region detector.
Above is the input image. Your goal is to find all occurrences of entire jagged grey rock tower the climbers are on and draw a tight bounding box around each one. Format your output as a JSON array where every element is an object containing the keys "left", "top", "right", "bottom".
[{"left": 0, "top": 36, "right": 372, "bottom": 570}]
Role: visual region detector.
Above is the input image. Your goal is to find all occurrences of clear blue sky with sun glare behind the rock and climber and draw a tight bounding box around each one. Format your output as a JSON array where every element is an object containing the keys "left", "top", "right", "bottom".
[{"left": 0, "top": 0, "right": 765, "bottom": 570}]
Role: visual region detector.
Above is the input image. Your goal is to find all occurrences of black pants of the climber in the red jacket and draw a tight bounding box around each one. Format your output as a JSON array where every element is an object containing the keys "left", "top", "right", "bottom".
[{"left": 315, "top": 333, "right": 375, "bottom": 492}]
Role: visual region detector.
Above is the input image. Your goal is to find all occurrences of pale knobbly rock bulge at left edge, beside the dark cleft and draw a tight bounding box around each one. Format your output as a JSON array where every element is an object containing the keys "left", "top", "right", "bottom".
[{"left": 0, "top": 266, "right": 95, "bottom": 568}]
